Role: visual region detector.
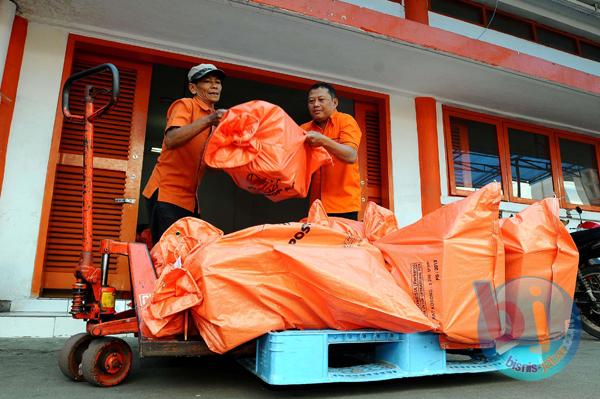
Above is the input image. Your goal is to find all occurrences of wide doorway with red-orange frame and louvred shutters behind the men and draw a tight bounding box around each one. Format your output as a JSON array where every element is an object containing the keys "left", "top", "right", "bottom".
[{"left": 31, "top": 34, "right": 393, "bottom": 296}]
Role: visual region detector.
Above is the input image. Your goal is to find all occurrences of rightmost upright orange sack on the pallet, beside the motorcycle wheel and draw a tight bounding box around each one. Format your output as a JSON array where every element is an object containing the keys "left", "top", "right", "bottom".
[{"left": 501, "top": 198, "right": 579, "bottom": 341}]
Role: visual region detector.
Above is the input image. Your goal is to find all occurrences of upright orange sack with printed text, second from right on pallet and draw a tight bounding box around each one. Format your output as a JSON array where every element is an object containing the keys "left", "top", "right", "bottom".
[{"left": 374, "top": 183, "right": 504, "bottom": 347}]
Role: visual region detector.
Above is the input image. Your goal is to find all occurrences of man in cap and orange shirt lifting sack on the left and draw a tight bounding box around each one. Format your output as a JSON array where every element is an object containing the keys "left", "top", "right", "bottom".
[{"left": 142, "top": 64, "right": 225, "bottom": 242}]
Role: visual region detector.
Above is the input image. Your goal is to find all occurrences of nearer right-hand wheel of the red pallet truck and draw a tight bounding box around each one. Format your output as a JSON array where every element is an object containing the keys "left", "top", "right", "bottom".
[{"left": 81, "top": 337, "right": 132, "bottom": 387}]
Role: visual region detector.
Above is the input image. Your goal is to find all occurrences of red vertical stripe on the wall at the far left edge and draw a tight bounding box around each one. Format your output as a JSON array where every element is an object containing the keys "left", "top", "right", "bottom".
[{"left": 0, "top": 16, "right": 27, "bottom": 193}]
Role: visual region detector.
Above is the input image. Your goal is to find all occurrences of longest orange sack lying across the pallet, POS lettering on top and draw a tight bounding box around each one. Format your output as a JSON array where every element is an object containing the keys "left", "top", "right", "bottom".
[{"left": 143, "top": 222, "right": 437, "bottom": 353}]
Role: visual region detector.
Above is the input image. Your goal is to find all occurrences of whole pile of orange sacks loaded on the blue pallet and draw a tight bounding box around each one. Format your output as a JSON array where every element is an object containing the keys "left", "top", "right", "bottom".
[{"left": 142, "top": 183, "right": 578, "bottom": 353}]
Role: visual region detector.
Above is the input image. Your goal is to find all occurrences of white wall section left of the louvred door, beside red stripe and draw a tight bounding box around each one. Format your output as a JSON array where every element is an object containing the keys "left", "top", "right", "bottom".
[{"left": 0, "top": 23, "right": 67, "bottom": 299}]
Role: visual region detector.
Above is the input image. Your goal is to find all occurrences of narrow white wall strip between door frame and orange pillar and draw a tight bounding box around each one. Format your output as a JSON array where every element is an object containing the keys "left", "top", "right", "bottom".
[{"left": 390, "top": 95, "right": 421, "bottom": 227}]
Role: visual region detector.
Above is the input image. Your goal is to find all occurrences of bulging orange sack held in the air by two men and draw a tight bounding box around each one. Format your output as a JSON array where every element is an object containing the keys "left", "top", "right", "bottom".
[{"left": 204, "top": 101, "right": 331, "bottom": 202}]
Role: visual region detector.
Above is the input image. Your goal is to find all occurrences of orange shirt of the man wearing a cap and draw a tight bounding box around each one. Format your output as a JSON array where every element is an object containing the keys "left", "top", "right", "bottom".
[{"left": 142, "top": 97, "right": 214, "bottom": 212}]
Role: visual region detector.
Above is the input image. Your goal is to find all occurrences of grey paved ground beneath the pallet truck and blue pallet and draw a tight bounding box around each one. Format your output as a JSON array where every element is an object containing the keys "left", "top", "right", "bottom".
[{"left": 0, "top": 334, "right": 600, "bottom": 399}]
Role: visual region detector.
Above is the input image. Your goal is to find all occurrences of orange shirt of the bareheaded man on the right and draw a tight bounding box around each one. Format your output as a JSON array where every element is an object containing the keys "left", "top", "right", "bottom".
[{"left": 300, "top": 111, "right": 362, "bottom": 213}]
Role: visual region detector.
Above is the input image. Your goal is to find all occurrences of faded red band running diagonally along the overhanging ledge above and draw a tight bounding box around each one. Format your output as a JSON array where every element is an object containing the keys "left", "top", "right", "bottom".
[{"left": 251, "top": 0, "right": 600, "bottom": 94}]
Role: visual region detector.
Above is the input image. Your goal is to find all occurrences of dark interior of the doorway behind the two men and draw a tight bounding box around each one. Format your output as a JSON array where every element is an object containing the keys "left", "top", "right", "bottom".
[{"left": 138, "top": 65, "right": 354, "bottom": 233}]
